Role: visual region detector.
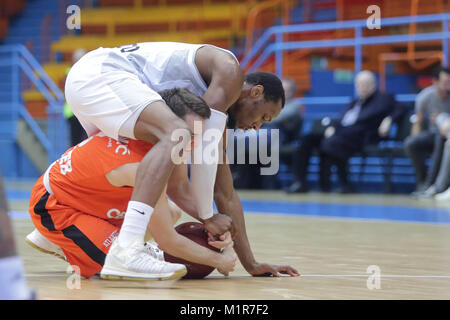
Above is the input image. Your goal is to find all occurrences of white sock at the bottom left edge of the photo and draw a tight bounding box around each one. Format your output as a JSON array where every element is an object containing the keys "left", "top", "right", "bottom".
[{"left": 0, "top": 256, "right": 34, "bottom": 300}]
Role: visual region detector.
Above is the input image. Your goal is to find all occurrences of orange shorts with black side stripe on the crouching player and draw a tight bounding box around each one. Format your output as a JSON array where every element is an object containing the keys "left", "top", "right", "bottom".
[{"left": 29, "top": 177, "right": 123, "bottom": 278}]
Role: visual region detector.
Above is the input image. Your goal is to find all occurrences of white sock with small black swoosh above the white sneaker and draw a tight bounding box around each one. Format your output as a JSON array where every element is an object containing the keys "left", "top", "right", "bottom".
[{"left": 118, "top": 201, "right": 153, "bottom": 247}]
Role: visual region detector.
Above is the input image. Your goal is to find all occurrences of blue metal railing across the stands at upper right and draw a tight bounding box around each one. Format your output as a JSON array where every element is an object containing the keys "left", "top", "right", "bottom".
[{"left": 241, "top": 13, "right": 450, "bottom": 104}]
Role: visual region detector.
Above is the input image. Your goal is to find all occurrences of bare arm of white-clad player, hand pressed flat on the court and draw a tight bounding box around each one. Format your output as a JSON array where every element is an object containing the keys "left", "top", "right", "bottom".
[{"left": 214, "top": 136, "right": 299, "bottom": 276}]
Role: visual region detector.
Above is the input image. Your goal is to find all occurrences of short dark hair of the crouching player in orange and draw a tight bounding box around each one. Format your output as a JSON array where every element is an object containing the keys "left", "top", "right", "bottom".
[{"left": 158, "top": 88, "right": 211, "bottom": 119}]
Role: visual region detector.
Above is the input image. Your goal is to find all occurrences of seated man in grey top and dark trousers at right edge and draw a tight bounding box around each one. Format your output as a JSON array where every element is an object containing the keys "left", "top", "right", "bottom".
[{"left": 405, "top": 67, "right": 450, "bottom": 197}]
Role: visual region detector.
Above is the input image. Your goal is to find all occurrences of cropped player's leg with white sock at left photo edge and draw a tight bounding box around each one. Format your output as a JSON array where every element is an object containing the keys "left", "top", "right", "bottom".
[{"left": 0, "top": 175, "right": 34, "bottom": 300}]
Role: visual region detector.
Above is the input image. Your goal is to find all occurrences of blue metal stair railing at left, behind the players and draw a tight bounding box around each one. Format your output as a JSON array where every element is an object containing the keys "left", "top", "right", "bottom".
[{"left": 0, "top": 44, "right": 67, "bottom": 166}]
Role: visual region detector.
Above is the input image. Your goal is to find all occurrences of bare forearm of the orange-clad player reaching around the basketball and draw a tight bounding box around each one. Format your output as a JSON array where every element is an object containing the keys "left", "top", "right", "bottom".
[{"left": 149, "top": 192, "right": 237, "bottom": 274}]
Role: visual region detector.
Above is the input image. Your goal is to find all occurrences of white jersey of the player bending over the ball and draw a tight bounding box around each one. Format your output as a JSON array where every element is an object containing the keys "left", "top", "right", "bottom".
[{"left": 102, "top": 42, "right": 237, "bottom": 97}]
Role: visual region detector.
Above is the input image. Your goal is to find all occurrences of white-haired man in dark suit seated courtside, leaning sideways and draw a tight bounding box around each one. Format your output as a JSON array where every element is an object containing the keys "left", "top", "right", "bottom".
[{"left": 288, "top": 71, "right": 406, "bottom": 193}]
